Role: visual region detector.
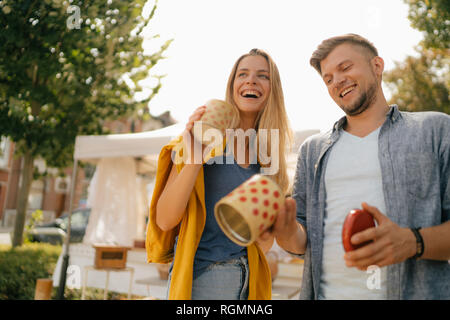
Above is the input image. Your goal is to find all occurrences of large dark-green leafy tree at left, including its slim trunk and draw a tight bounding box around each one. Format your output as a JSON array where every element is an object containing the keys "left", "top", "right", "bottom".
[{"left": 0, "top": 0, "right": 171, "bottom": 246}]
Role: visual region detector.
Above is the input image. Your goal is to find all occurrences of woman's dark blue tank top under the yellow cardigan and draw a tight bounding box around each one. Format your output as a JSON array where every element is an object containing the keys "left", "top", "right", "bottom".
[{"left": 194, "top": 155, "right": 260, "bottom": 279}]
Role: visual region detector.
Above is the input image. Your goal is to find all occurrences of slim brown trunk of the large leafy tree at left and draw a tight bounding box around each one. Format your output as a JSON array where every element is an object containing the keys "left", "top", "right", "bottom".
[{"left": 12, "top": 151, "right": 34, "bottom": 247}]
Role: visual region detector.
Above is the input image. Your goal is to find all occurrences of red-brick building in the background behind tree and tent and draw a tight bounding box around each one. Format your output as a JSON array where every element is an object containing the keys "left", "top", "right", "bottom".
[{"left": 0, "top": 112, "right": 175, "bottom": 227}]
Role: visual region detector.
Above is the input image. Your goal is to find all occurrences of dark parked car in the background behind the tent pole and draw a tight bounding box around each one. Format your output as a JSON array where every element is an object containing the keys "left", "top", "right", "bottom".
[{"left": 30, "top": 208, "right": 91, "bottom": 244}]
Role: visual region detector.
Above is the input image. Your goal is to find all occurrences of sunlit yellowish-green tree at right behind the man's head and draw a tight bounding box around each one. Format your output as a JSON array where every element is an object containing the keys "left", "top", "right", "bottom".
[{"left": 384, "top": 0, "right": 450, "bottom": 114}]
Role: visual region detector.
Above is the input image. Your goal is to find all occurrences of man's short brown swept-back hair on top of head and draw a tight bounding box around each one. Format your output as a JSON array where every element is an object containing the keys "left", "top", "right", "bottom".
[{"left": 309, "top": 33, "right": 378, "bottom": 74}]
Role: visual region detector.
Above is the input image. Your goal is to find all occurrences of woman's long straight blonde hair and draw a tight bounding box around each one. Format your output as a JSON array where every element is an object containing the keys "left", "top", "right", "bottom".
[{"left": 225, "top": 49, "right": 292, "bottom": 192}]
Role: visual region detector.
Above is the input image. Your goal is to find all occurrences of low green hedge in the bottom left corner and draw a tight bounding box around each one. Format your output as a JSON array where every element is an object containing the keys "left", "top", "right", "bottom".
[{"left": 0, "top": 244, "right": 61, "bottom": 300}]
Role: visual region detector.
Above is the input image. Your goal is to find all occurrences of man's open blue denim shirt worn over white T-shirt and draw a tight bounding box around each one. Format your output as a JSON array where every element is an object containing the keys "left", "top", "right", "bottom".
[{"left": 293, "top": 105, "right": 450, "bottom": 299}]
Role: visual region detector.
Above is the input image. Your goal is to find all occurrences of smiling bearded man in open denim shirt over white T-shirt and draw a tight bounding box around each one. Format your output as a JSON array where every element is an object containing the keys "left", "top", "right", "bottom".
[{"left": 272, "top": 34, "right": 450, "bottom": 299}]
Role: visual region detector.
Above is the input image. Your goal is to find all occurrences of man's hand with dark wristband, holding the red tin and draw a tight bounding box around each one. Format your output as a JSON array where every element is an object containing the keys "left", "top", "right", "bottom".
[{"left": 344, "top": 202, "right": 416, "bottom": 271}]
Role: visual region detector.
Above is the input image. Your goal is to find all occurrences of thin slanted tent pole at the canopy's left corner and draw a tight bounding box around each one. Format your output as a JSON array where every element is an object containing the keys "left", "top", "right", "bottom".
[{"left": 58, "top": 159, "right": 78, "bottom": 300}]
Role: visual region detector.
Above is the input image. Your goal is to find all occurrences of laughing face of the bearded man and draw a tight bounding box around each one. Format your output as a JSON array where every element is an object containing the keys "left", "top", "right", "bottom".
[{"left": 320, "top": 43, "right": 380, "bottom": 116}]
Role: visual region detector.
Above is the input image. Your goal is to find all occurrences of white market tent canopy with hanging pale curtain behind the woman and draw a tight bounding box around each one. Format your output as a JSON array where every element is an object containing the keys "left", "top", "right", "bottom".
[{"left": 74, "top": 124, "right": 184, "bottom": 246}]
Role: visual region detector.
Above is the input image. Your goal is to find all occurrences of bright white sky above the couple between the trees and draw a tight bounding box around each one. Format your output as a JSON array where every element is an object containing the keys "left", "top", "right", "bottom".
[{"left": 139, "top": 0, "right": 423, "bottom": 131}]
